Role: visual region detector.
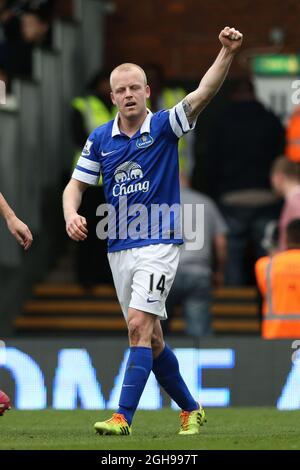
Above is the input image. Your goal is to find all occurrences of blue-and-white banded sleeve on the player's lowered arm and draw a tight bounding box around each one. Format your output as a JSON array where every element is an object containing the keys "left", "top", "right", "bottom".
[{"left": 72, "top": 132, "right": 101, "bottom": 185}]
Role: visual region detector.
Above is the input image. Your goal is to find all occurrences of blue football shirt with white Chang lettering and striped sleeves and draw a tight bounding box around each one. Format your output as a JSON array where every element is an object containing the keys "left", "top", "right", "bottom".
[{"left": 72, "top": 102, "right": 195, "bottom": 252}]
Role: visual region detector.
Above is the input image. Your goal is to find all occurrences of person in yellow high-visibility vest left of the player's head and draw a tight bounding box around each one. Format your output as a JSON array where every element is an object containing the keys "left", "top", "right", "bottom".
[{"left": 70, "top": 71, "right": 116, "bottom": 288}]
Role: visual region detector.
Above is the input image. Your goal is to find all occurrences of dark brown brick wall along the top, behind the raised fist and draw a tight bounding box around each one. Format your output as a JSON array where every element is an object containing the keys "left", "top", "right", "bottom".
[{"left": 105, "top": 0, "right": 300, "bottom": 80}]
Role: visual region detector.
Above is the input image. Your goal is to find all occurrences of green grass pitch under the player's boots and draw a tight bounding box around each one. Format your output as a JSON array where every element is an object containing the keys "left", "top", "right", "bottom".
[{"left": 0, "top": 408, "right": 300, "bottom": 450}]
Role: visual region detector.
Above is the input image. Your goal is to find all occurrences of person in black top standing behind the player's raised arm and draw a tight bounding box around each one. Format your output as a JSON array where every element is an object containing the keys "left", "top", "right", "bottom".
[{"left": 206, "top": 79, "right": 285, "bottom": 286}]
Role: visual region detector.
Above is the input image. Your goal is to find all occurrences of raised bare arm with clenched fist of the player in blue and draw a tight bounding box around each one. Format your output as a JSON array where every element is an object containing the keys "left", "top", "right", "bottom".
[{"left": 183, "top": 26, "right": 243, "bottom": 124}]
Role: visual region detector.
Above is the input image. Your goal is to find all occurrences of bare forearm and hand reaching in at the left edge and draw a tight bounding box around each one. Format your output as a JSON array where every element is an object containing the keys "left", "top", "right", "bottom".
[{"left": 0, "top": 193, "right": 33, "bottom": 250}]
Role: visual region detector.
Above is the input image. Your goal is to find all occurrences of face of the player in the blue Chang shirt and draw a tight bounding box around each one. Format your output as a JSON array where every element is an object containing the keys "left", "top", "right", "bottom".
[{"left": 111, "top": 69, "right": 150, "bottom": 119}]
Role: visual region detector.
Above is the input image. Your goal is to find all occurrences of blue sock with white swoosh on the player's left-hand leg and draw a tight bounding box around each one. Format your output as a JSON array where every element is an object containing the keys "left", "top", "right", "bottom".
[{"left": 117, "top": 346, "right": 153, "bottom": 425}]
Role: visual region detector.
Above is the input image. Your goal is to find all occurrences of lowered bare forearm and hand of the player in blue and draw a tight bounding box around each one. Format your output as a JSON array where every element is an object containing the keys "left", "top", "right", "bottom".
[{"left": 63, "top": 178, "right": 89, "bottom": 242}]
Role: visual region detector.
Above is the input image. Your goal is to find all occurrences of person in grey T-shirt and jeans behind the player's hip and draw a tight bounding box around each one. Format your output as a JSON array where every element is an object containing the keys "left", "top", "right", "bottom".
[{"left": 167, "top": 172, "right": 227, "bottom": 338}]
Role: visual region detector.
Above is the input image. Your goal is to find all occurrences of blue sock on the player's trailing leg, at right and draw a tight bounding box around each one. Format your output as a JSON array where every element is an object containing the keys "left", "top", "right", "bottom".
[{"left": 152, "top": 345, "right": 199, "bottom": 411}]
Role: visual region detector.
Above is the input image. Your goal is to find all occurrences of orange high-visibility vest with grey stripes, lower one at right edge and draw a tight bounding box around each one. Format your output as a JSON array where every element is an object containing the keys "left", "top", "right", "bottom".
[{"left": 255, "top": 249, "right": 300, "bottom": 339}]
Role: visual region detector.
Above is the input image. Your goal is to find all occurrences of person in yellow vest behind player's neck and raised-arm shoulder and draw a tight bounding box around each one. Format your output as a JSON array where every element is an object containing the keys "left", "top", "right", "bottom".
[{"left": 145, "top": 64, "right": 195, "bottom": 178}]
